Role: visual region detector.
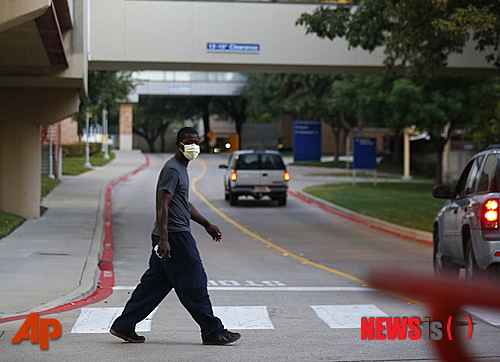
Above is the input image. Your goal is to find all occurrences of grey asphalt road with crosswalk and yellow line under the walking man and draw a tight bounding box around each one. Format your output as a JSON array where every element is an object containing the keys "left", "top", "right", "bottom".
[{"left": 0, "top": 154, "right": 500, "bottom": 361}]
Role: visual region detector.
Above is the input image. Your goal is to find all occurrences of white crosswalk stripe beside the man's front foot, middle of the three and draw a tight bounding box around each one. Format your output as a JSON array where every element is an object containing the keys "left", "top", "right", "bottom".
[{"left": 213, "top": 306, "right": 274, "bottom": 329}]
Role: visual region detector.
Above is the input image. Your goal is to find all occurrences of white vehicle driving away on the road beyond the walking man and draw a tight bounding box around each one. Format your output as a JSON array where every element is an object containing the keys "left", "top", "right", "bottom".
[{"left": 219, "top": 151, "right": 290, "bottom": 206}]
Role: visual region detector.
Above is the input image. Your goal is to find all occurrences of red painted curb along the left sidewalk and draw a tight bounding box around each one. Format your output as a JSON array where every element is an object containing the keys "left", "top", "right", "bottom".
[{"left": 0, "top": 155, "right": 150, "bottom": 324}]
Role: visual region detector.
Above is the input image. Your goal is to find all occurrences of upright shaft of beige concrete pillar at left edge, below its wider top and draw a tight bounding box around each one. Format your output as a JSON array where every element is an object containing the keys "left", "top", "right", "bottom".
[{"left": 0, "top": 122, "right": 41, "bottom": 219}]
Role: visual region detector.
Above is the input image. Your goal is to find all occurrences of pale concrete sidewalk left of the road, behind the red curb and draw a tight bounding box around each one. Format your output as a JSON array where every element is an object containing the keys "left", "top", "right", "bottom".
[{"left": 0, "top": 151, "right": 146, "bottom": 318}]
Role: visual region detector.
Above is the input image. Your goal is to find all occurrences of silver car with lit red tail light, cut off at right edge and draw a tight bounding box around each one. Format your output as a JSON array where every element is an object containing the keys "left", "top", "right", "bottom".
[{"left": 432, "top": 145, "right": 500, "bottom": 280}]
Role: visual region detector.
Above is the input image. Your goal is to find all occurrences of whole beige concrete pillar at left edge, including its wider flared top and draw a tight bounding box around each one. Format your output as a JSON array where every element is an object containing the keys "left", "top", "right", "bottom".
[{"left": 0, "top": 88, "right": 79, "bottom": 219}]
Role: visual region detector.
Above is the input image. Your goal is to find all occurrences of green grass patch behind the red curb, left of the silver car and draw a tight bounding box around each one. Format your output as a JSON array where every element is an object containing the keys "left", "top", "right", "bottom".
[{"left": 304, "top": 182, "right": 444, "bottom": 231}]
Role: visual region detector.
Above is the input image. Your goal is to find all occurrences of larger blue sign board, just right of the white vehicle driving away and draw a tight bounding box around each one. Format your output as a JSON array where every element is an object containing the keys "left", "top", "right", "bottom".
[{"left": 293, "top": 120, "right": 321, "bottom": 161}]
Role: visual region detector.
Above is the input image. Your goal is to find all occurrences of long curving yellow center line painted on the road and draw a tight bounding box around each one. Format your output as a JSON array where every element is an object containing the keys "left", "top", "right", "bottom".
[{"left": 192, "top": 158, "right": 423, "bottom": 304}]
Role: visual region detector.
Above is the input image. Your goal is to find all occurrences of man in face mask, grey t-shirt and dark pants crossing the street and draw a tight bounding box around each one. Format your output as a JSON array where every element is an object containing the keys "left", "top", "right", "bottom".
[{"left": 110, "top": 127, "right": 241, "bottom": 345}]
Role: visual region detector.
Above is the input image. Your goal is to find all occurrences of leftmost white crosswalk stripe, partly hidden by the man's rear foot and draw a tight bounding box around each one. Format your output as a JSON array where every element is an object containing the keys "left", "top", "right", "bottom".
[{"left": 71, "top": 307, "right": 156, "bottom": 333}]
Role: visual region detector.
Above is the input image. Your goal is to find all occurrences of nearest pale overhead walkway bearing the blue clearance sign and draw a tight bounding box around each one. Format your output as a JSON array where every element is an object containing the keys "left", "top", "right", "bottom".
[{"left": 88, "top": 0, "right": 497, "bottom": 75}]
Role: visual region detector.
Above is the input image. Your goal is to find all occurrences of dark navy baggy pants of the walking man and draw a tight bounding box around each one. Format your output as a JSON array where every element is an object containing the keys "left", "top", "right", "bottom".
[{"left": 111, "top": 232, "right": 224, "bottom": 340}]
